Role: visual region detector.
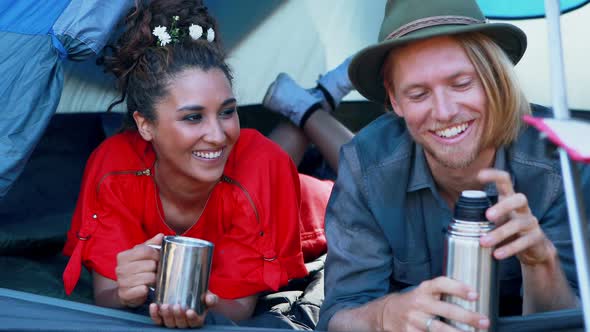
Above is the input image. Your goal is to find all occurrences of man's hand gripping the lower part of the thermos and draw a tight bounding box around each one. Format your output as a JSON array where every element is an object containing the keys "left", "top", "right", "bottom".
[{"left": 381, "top": 277, "right": 490, "bottom": 331}]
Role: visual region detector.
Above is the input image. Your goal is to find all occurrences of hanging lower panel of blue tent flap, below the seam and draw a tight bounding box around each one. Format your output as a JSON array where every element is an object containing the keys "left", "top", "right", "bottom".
[{"left": 0, "top": 32, "right": 63, "bottom": 199}]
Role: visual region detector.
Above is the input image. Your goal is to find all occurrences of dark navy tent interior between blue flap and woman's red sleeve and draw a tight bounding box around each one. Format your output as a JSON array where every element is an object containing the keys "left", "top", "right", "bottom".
[{"left": 0, "top": 113, "right": 105, "bottom": 255}]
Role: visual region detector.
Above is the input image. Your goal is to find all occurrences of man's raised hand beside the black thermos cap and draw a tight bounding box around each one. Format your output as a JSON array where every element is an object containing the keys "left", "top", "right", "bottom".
[{"left": 478, "top": 169, "right": 556, "bottom": 266}]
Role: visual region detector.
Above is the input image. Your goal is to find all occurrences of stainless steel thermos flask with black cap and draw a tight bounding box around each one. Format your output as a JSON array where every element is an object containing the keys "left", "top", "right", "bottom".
[{"left": 443, "top": 190, "right": 499, "bottom": 331}]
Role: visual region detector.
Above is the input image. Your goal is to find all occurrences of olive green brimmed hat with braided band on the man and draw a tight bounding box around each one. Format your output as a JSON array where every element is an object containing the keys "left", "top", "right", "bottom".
[{"left": 348, "top": 0, "right": 526, "bottom": 103}]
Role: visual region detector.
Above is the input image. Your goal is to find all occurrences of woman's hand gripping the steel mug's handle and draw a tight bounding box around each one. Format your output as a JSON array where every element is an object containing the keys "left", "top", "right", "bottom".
[{"left": 115, "top": 234, "right": 164, "bottom": 307}]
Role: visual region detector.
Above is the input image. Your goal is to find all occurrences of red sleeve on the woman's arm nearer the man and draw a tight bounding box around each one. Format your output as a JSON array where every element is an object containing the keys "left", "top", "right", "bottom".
[{"left": 210, "top": 131, "right": 307, "bottom": 298}]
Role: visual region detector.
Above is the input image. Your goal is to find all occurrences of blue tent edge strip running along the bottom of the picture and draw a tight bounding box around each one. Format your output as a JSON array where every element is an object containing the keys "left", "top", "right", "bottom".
[{"left": 0, "top": 288, "right": 584, "bottom": 332}]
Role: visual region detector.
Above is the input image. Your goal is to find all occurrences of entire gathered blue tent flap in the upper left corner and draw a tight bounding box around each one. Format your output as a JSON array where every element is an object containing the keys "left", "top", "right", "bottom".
[{"left": 0, "top": 0, "right": 132, "bottom": 200}]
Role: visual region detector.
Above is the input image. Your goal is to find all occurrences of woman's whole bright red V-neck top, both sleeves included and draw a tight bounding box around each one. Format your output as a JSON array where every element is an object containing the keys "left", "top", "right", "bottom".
[{"left": 63, "top": 129, "right": 332, "bottom": 299}]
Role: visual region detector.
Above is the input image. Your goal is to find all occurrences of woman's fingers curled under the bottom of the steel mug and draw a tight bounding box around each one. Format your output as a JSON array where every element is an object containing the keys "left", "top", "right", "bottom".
[{"left": 150, "top": 291, "right": 218, "bottom": 329}]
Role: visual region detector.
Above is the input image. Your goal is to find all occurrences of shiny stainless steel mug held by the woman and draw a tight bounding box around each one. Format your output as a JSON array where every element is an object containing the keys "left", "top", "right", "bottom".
[{"left": 149, "top": 236, "right": 214, "bottom": 315}]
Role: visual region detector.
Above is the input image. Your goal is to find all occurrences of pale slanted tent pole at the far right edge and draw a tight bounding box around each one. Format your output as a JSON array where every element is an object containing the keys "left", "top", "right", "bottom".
[{"left": 545, "top": 0, "right": 590, "bottom": 332}]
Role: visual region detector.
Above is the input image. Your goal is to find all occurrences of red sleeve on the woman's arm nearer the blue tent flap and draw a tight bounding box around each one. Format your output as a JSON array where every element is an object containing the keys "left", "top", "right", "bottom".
[{"left": 63, "top": 134, "right": 154, "bottom": 294}]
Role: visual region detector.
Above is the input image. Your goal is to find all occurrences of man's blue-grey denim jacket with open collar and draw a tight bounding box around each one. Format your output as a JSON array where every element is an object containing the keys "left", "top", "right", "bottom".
[{"left": 318, "top": 106, "right": 590, "bottom": 330}]
